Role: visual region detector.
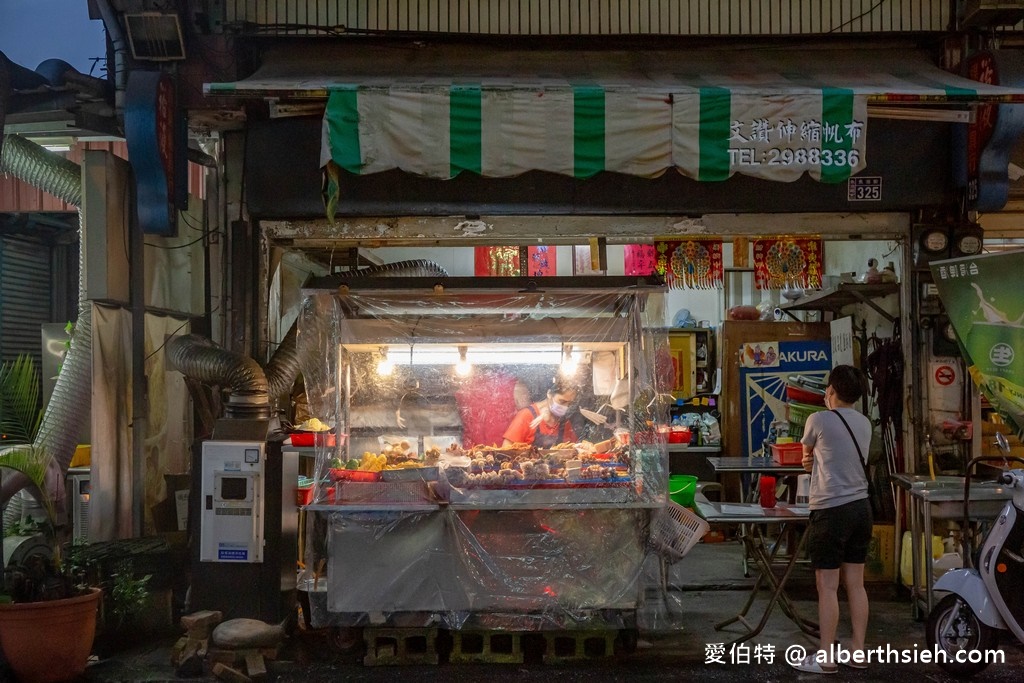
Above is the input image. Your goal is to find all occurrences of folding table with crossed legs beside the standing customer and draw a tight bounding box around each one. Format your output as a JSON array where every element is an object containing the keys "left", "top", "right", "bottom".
[{"left": 695, "top": 500, "right": 818, "bottom": 645}]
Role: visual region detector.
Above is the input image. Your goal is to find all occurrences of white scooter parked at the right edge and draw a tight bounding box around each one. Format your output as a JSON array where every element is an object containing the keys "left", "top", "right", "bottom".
[{"left": 926, "top": 434, "right": 1024, "bottom": 676}]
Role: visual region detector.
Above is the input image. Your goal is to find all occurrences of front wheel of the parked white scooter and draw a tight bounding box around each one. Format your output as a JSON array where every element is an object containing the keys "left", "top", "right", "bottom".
[{"left": 925, "top": 593, "right": 998, "bottom": 676}]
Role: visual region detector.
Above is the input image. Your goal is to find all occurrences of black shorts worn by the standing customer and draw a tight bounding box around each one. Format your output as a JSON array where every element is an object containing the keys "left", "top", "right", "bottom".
[{"left": 807, "top": 498, "right": 871, "bottom": 569}]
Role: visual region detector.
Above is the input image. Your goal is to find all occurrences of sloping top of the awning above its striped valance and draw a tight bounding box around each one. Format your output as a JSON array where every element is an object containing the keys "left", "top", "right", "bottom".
[{"left": 204, "top": 45, "right": 1024, "bottom": 103}]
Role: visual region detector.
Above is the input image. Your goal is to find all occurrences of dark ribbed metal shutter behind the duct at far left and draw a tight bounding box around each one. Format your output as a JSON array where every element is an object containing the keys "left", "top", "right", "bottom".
[{"left": 0, "top": 237, "right": 51, "bottom": 368}]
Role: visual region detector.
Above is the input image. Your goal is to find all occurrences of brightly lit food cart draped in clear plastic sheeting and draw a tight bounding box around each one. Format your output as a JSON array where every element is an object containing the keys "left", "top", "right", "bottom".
[{"left": 299, "top": 278, "right": 671, "bottom": 647}]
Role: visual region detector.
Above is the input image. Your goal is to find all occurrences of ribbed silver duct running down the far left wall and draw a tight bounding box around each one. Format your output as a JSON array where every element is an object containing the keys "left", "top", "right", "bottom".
[{"left": 0, "top": 135, "right": 92, "bottom": 528}]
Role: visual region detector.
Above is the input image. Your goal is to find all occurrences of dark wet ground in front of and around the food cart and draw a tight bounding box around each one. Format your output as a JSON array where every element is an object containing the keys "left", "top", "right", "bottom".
[{"left": 74, "top": 543, "right": 1024, "bottom": 683}]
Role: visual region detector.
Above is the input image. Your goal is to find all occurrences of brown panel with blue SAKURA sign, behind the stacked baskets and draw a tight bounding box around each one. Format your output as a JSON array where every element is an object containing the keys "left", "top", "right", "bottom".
[{"left": 719, "top": 321, "right": 831, "bottom": 457}]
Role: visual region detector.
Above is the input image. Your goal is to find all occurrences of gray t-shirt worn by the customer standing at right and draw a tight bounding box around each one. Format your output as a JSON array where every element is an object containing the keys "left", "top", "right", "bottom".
[{"left": 800, "top": 408, "right": 871, "bottom": 510}]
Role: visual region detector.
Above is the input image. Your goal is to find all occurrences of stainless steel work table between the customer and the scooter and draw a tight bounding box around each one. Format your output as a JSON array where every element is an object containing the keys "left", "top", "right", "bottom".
[{"left": 892, "top": 474, "right": 1011, "bottom": 618}]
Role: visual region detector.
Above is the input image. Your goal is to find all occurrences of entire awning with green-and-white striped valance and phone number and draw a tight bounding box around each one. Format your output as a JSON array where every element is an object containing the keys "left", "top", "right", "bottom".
[{"left": 205, "top": 46, "right": 1024, "bottom": 182}]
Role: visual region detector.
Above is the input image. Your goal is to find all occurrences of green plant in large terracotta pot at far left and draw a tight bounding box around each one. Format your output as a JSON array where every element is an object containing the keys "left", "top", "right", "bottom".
[{"left": 0, "top": 355, "right": 102, "bottom": 682}]
